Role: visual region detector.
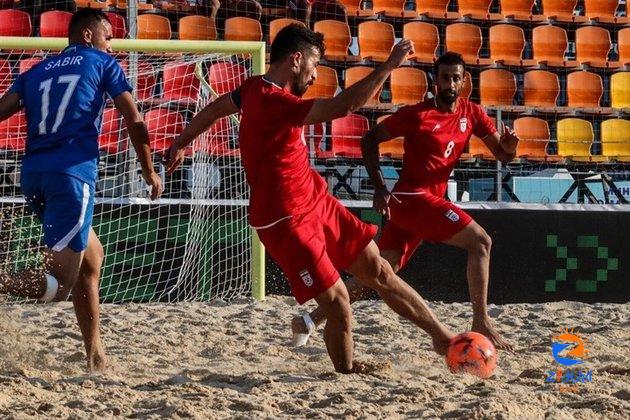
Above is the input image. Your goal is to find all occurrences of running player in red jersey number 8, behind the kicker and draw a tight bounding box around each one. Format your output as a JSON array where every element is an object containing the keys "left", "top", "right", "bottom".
[{"left": 292, "top": 52, "right": 519, "bottom": 349}]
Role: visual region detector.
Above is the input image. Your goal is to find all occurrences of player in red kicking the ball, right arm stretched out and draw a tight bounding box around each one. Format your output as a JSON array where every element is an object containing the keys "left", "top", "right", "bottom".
[{"left": 167, "top": 24, "right": 460, "bottom": 373}]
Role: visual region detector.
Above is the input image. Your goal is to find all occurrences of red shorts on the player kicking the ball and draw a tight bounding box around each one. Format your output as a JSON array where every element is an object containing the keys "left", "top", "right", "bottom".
[{"left": 257, "top": 194, "right": 377, "bottom": 304}]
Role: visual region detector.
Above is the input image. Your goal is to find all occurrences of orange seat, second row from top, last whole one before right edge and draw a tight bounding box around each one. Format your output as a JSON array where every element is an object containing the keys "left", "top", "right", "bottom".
[{"left": 575, "top": 26, "right": 618, "bottom": 68}]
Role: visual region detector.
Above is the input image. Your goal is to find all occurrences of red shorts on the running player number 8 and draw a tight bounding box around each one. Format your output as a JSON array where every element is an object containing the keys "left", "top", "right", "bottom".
[{"left": 378, "top": 192, "right": 473, "bottom": 268}]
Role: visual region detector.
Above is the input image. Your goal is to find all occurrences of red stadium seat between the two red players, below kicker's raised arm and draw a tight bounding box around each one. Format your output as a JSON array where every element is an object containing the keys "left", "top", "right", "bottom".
[{"left": 330, "top": 114, "right": 370, "bottom": 159}]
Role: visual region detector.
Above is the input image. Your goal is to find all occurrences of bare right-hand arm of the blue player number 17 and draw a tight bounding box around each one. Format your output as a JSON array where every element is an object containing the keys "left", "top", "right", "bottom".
[{"left": 114, "top": 91, "right": 163, "bottom": 200}]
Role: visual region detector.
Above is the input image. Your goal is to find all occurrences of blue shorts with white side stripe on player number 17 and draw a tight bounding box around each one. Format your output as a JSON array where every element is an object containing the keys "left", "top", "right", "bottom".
[{"left": 21, "top": 173, "right": 94, "bottom": 252}]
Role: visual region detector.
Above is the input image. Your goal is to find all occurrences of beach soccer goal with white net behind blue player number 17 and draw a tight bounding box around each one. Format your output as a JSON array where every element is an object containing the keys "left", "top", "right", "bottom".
[{"left": 0, "top": 38, "right": 264, "bottom": 302}]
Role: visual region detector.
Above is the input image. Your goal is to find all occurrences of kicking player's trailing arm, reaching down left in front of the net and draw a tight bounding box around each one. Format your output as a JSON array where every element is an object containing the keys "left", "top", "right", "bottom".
[{"left": 165, "top": 89, "right": 240, "bottom": 175}]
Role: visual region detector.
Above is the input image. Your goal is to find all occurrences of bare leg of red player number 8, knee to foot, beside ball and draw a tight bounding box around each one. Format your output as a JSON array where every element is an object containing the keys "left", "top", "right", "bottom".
[{"left": 444, "top": 221, "right": 511, "bottom": 349}]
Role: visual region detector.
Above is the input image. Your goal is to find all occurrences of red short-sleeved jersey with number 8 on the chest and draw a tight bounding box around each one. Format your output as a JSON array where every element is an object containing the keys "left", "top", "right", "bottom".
[{"left": 384, "top": 98, "right": 497, "bottom": 197}]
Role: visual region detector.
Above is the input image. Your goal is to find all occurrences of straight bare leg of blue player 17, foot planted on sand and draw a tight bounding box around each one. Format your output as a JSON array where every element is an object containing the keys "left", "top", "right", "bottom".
[{"left": 72, "top": 229, "right": 107, "bottom": 372}]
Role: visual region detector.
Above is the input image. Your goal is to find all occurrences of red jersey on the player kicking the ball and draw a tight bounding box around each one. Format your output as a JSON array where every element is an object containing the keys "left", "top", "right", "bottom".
[{"left": 231, "top": 76, "right": 327, "bottom": 228}]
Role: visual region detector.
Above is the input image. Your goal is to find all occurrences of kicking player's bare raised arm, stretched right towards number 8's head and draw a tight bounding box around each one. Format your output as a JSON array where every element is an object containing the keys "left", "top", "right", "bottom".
[{"left": 304, "top": 40, "right": 414, "bottom": 125}]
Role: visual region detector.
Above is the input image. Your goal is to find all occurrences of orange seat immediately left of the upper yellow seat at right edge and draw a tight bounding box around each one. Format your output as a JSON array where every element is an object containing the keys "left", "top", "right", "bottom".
[{"left": 567, "top": 71, "right": 610, "bottom": 114}]
